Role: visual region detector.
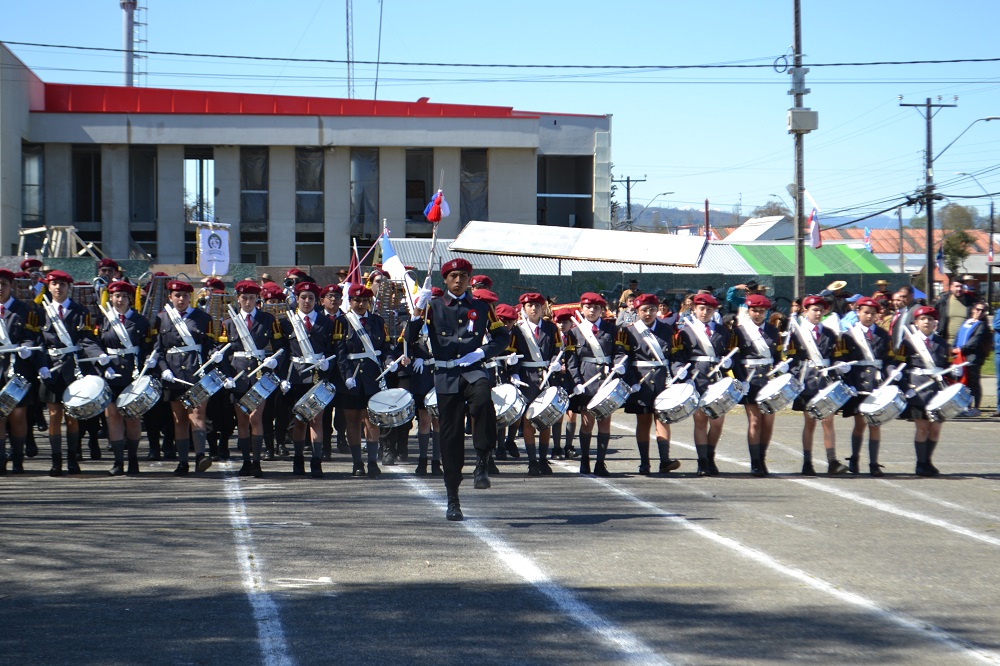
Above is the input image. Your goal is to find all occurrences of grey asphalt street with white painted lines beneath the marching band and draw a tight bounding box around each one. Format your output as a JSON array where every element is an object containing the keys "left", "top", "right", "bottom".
[{"left": 0, "top": 407, "right": 1000, "bottom": 665}]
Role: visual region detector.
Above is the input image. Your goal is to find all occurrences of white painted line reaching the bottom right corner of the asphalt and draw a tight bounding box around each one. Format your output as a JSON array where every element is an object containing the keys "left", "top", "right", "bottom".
[{"left": 604, "top": 423, "right": 1000, "bottom": 664}]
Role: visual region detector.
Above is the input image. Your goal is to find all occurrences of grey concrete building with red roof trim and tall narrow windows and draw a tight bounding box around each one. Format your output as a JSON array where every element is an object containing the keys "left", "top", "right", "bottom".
[{"left": 0, "top": 44, "right": 611, "bottom": 265}]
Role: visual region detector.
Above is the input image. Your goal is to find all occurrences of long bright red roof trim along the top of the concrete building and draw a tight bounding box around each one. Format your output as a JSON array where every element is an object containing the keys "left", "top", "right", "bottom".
[{"left": 45, "top": 83, "right": 538, "bottom": 119}]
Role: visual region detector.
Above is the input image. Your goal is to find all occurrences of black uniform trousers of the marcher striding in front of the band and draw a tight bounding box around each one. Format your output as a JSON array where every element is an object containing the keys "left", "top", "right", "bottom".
[{"left": 438, "top": 378, "right": 497, "bottom": 488}]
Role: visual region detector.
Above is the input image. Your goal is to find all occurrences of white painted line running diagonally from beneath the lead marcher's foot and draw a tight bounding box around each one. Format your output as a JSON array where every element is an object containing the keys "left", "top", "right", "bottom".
[{"left": 390, "top": 468, "right": 670, "bottom": 664}]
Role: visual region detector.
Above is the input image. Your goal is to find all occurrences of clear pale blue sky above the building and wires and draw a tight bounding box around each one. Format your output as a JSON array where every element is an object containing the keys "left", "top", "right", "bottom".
[{"left": 0, "top": 0, "right": 1000, "bottom": 222}]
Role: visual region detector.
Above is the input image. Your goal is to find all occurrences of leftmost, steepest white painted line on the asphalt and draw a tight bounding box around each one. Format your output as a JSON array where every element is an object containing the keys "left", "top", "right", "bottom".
[{"left": 223, "top": 463, "right": 295, "bottom": 666}]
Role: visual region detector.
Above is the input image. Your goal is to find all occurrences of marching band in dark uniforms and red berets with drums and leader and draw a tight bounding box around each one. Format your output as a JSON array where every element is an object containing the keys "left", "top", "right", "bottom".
[{"left": 0, "top": 259, "right": 984, "bottom": 520}]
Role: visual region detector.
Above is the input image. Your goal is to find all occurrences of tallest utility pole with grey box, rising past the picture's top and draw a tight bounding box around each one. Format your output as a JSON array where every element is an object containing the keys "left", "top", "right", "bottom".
[{"left": 788, "top": 0, "right": 819, "bottom": 298}]
